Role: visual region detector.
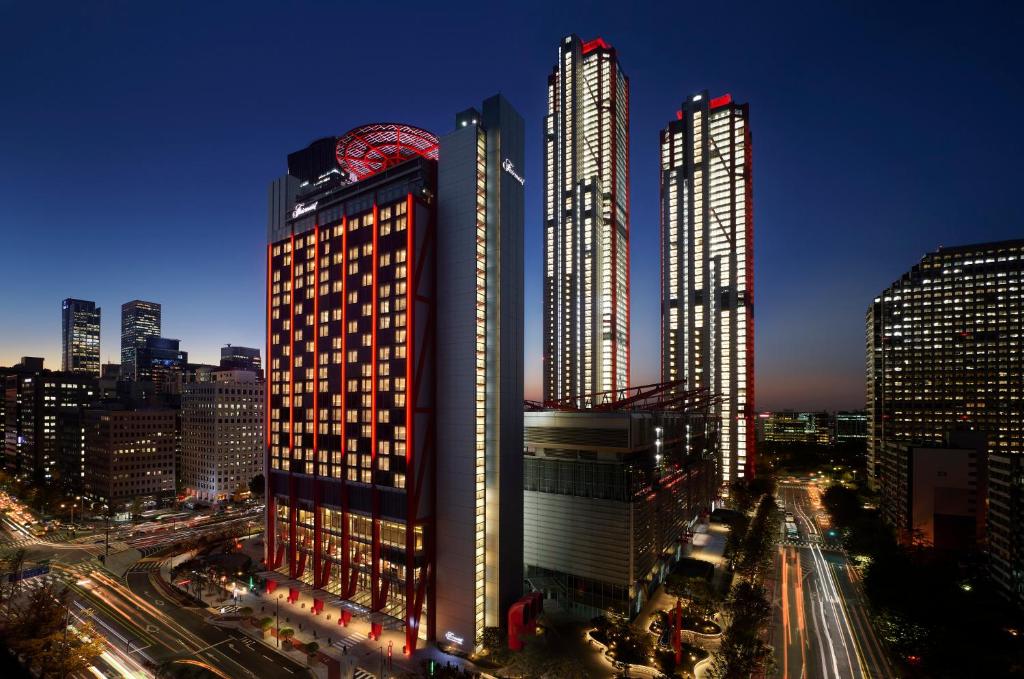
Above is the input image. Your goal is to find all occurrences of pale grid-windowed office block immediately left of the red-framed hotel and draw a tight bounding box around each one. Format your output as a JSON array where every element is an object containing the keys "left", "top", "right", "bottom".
[{"left": 180, "top": 370, "right": 264, "bottom": 504}]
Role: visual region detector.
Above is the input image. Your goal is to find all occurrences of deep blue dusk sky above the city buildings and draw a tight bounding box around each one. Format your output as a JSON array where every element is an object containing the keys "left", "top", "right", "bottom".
[{"left": 0, "top": 0, "right": 1024, "bottom": 409}]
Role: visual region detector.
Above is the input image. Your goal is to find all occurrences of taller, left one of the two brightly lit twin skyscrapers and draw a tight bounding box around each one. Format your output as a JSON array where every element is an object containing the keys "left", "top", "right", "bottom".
[{"left": 544, "top": 35, "right": 630, "bottom": 400}]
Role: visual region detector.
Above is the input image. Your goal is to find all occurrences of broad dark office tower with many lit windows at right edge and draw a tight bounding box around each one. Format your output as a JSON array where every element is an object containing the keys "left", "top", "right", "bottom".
[{"left": 866, "top": 241, "right": 1024, "bottom": 602}]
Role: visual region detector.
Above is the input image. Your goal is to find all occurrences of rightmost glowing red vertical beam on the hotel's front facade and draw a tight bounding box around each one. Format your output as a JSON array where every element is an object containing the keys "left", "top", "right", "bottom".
[{"left": 404, "top": 194, "right": 420, "bottom": 654}]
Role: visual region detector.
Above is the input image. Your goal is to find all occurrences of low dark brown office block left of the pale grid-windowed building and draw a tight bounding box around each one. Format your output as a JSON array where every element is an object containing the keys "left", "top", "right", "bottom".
[{"left": 84, "top": 405, "right": 177, "bottom": 513}]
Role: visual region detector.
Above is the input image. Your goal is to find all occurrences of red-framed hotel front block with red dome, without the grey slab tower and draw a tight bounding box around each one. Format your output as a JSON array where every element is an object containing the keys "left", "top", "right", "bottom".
[{"left": 265, "top": 130, "right": 437, "bottom": 652}]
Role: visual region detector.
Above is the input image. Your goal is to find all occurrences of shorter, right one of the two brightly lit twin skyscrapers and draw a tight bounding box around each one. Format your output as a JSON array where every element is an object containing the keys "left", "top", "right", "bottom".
[{"left": 660, "top": 91, "right": 755, "bottom": 486}]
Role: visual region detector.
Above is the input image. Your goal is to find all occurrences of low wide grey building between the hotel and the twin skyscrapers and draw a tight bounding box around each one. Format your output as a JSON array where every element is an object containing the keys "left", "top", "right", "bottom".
[{"left": 523, "top": 399, "right": 718, "bottom": 620}]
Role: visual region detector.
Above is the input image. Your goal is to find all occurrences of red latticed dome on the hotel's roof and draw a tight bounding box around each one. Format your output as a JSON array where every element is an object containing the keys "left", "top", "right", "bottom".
[{"left": 335, "top": 123, "right": 437, "bottom": 181}]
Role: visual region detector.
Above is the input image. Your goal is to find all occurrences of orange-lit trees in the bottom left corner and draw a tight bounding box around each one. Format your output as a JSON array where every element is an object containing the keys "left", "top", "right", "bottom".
[{"left": 0, "top": 550, "right": 103, "bottom": 678}]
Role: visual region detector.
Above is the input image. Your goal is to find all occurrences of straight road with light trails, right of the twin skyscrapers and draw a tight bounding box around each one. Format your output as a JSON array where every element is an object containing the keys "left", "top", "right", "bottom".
[{"left": 772, "top": 483, "right": 897, "bottom": 679}]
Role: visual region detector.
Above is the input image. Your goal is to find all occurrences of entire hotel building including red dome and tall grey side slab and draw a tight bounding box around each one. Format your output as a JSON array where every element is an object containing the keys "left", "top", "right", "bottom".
[{"left": 266, "top": 103, "right": 524, "bottom": 651}]
